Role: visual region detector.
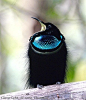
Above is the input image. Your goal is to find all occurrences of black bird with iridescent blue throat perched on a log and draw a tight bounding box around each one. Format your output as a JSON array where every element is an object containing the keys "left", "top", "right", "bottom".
[{"left": 27, "top": 17, "right": 67, "bottom": 88}]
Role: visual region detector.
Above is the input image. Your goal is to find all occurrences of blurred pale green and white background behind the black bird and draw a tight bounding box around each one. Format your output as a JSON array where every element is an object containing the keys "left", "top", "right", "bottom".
[{"left": 0, "top": 0, "right": 86, "bottom": 94}]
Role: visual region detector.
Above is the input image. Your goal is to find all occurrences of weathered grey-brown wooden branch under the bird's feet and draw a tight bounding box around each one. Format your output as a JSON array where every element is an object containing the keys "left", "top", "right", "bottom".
[{"left": 0, "top": 81, "right": 86, "bottom": 100}]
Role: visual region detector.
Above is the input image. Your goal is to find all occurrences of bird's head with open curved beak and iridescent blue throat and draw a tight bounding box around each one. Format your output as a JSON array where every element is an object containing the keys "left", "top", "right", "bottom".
[{"left": 30, "top": 17, "right": 64, "bottom": 51}]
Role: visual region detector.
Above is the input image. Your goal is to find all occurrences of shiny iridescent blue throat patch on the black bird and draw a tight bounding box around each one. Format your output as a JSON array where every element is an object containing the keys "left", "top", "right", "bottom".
[{"left": 32, "top": 35, "right": 61, "bottom": 50}]
